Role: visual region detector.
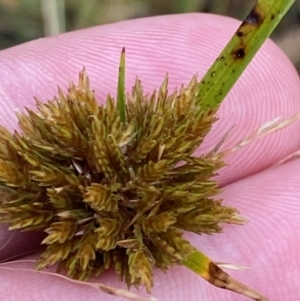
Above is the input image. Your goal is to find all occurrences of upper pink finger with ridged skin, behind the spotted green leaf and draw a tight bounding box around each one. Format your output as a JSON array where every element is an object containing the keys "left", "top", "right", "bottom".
[{"left": 0, "top": 14, "right": 300, "bottom": 184}]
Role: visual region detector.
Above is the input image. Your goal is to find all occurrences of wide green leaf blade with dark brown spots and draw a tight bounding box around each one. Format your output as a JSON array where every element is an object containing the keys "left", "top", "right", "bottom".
[{"left": 198, "top": 0, "right": 295, "bottom": 107}]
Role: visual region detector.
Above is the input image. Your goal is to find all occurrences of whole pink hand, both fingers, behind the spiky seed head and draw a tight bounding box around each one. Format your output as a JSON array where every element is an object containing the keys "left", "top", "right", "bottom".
[{"left": 0, "top": 14, "right": 300, "bottom": 301}]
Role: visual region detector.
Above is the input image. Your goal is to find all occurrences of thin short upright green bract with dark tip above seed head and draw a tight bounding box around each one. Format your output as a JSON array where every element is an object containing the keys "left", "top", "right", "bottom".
[{"left": 117, "top": 48, "right": 126, "bottom": 123}]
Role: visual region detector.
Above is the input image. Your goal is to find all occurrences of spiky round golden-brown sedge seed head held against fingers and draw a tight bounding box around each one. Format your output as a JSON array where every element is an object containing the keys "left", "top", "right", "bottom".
[{"left": 0, "top": 71, "right": 237, "bottom": 291}]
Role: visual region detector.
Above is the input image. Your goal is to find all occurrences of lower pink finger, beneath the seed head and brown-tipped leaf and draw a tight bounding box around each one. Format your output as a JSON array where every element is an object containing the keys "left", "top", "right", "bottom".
[{"left": 0, "top": 160, "right": 300, "bottom": 301}]
